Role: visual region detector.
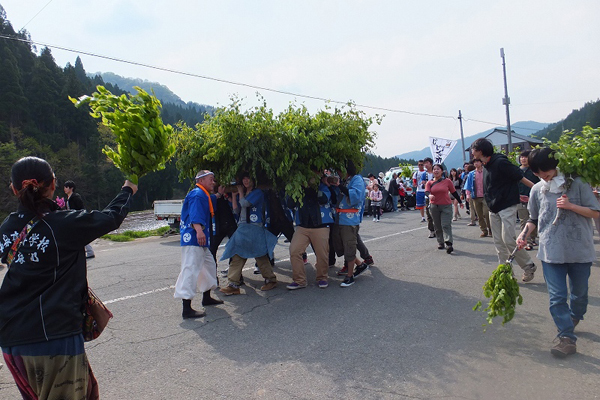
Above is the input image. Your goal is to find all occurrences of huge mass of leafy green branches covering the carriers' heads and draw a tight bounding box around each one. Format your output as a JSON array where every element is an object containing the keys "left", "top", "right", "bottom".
[{"left": 175, "top": 98, "right": 381, "bottom": 200}]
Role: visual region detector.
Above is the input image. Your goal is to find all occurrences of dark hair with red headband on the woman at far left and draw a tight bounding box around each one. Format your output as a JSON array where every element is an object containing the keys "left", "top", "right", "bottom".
[{"left": 10, "top": 157, "right": 54, "bottom": 217}]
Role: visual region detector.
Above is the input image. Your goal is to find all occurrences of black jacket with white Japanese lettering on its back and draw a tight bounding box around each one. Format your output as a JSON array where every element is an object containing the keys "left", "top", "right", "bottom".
[{"left": 0, "top": 187, "right": 133, "bottom": 347}]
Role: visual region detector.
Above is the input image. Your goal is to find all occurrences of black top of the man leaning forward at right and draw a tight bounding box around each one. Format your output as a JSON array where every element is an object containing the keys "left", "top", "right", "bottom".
[{"left": 483, "top": 153, "right": 523, "bottom": 213}]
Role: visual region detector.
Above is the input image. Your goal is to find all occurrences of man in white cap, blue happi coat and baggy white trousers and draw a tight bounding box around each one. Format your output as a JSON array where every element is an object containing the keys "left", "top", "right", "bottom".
[{"left": 173, "top": 170, "right": 223, "bottom": 319}]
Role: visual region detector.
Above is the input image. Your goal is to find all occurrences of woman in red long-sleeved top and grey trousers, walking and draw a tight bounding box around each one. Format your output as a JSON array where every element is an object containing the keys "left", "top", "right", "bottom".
[{"left": 425, "top": 164, "right": 464, "bottom": 254}]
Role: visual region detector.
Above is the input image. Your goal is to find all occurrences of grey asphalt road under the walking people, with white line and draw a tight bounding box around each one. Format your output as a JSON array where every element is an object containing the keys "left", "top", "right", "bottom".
[{"left": 0, "top": 211, "right": 600, "bottom": 400}]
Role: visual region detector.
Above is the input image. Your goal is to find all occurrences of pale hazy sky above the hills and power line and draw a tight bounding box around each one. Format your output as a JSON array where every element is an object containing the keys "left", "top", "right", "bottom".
[{"left": 0, "top": 0, "right": 600, "bottom": 157}]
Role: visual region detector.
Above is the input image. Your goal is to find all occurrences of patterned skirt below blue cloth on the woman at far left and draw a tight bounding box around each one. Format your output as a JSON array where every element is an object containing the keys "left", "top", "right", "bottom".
[{"left": 2, "top": 335, "right": 100, "bottom": 400}]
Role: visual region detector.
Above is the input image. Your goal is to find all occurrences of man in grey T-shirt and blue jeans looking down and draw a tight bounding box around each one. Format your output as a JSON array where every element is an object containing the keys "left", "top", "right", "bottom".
[{"left": 517, "top": 147, "right": 600, "bottom": 357}]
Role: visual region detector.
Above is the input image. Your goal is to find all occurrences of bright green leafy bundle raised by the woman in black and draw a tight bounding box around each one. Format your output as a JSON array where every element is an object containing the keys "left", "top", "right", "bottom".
[{"left": 69, "top": 85, "right": 175, "bottom": 184}]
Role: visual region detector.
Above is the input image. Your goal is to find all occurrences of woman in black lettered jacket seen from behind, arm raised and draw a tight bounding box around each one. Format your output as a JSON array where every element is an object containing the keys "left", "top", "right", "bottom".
[{"left": 0, "top": 157, "right": 137, "bottom": 399}]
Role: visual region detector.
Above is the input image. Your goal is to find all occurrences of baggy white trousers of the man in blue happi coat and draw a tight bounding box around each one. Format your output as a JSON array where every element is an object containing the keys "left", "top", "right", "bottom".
[{"left": 173, "top": 246, "right": 217, "bottom": 300}]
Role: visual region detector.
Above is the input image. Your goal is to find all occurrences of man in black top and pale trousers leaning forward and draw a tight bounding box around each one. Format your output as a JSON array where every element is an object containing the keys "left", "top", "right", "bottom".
[{"left": 471, "top": 138, "right": 536, "bottom": 282}]
